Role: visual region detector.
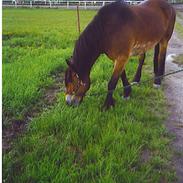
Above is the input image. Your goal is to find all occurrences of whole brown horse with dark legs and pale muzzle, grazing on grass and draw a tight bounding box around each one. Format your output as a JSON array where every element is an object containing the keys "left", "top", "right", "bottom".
[{"left": 65, "top": 0, "right": 176, "bottom": 109}]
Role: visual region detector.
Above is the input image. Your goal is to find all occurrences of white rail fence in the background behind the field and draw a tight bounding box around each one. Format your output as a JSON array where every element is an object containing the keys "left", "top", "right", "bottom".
[{"left": 2, "top": 0, "right": 183, "bottom": 9}]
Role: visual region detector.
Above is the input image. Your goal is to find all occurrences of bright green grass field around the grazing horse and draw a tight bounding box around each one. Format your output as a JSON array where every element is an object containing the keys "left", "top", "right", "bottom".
[{"left": 3, "top": 9, "right": 175, "bottom": 183}]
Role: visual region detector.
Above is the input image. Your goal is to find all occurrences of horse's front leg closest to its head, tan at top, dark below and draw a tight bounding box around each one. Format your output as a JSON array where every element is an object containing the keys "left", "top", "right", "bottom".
[{"left": 103, "top": 58, "right": 128, "bottom": 110}]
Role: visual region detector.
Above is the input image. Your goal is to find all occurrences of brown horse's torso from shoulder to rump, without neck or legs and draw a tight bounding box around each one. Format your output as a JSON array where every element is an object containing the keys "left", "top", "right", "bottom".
[{"left": 103, "top": 0, "right": 175, "bottom": 58}]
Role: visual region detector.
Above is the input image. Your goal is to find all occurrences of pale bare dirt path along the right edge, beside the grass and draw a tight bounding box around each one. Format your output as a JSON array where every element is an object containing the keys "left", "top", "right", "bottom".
[{"left": 164, "top": 6, "right": 183, "bottom": 183}]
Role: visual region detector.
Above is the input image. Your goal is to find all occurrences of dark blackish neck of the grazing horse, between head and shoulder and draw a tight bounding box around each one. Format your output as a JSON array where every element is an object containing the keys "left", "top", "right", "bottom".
[{"left": 73, "top": 15, "right": 103, "bottom": 78}]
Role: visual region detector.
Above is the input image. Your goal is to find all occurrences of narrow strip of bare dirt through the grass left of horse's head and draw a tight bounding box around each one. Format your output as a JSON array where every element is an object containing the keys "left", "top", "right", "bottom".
[{"left": 2, "top": 72, "right": 64, "bottom": 152}]
